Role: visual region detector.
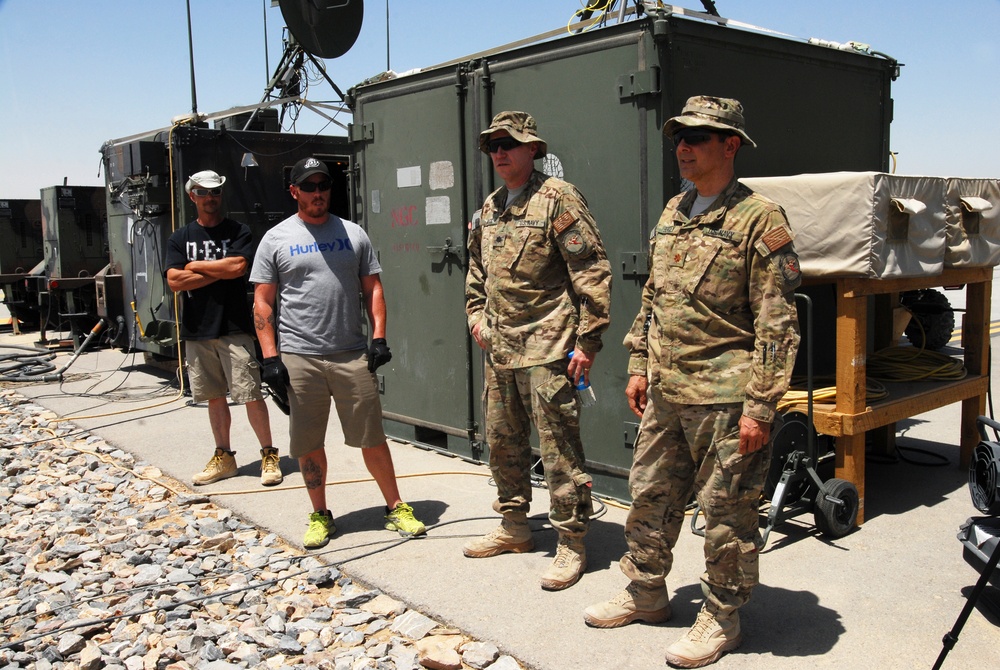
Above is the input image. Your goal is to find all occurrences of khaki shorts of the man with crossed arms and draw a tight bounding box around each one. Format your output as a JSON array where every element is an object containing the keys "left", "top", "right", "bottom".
[{"left": 184, "top": 333, "right": 264, "bottom": 405}]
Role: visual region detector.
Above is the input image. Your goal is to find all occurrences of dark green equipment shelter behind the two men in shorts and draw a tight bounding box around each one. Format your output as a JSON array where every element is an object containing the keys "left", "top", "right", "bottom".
[{"left": 97, "top": 121, "right": 352, "bottom": 361}]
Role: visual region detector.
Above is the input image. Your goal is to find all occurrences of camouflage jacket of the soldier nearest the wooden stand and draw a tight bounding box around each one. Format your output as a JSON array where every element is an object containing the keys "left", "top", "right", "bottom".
[{"left": 625, "top": 179, "right": 801, "bottom": 422}]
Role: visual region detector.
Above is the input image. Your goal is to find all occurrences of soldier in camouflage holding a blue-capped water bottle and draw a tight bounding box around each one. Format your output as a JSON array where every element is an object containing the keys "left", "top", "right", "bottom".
[{"left": 463, "top": 112, "right": 611, "bottom": 590}]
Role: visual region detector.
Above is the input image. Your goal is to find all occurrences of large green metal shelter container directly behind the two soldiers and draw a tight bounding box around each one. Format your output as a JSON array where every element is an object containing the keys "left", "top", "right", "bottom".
[{"left": 347, "top": 5, "right": 899, "bottom": 498}]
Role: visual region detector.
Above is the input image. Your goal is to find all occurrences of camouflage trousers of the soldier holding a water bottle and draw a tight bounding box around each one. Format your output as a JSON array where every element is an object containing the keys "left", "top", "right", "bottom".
[{"left": 484, "top": 361, "right": 591, "bottom": 537}]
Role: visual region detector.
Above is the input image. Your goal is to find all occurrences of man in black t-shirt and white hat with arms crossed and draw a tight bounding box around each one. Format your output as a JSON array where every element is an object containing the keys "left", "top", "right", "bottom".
[{"left": 165, "top": 170, "right": 282, "bottom": 486}]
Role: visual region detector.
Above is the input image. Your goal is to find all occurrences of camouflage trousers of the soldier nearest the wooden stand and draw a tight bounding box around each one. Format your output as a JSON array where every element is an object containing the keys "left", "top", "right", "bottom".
[{"left": 621, "top": 392, "right": 773, "bottom": 611}]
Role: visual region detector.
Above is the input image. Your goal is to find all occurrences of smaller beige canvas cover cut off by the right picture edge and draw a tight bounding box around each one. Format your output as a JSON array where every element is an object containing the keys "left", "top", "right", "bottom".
[{"left": 944, "top": 177, "right": 1000, "bottom": 268}]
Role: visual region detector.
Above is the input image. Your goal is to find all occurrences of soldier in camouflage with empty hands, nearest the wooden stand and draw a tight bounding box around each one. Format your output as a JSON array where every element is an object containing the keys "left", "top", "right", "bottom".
[{"left": 584, "top": 96, "right": 801, "bottom": 668}]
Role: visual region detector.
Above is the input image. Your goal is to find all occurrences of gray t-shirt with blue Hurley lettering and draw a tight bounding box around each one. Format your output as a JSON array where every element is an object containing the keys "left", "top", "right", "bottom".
[{"left": 250, "top": 214, "right": 382, "bottom": 356}]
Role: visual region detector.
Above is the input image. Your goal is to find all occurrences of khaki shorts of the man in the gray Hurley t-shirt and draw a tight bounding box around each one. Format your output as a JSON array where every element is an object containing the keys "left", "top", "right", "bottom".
[{"left": 281, "top": 349, "right": 386, "bottom": 458}]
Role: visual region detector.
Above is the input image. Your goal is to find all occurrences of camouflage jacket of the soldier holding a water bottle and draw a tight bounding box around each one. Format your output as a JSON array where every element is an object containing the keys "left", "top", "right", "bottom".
[{"left": 465, "top": 170, "right": 611, "bottom": 369}]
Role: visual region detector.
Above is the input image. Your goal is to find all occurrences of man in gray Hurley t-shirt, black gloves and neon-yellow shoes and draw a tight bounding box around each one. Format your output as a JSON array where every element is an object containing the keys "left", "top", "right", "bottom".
[{"left": 250, "top": 158, "right": 425, "bottom": 549}]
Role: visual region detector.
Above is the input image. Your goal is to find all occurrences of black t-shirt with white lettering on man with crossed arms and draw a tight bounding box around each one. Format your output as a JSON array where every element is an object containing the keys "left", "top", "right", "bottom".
[{"left": 164, "top": 219, "right": 254, "bottom": 340}]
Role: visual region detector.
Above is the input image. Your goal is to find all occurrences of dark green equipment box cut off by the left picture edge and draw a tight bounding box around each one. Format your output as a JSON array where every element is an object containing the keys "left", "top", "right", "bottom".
[{"left": 0, "top": 199, "right": 45, "bottom": 328}]
